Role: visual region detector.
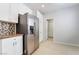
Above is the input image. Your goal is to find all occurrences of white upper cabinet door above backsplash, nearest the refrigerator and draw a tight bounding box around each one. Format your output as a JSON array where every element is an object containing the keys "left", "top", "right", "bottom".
[{"left": 9, "top": 3, "right": 18, "bottom": 23}]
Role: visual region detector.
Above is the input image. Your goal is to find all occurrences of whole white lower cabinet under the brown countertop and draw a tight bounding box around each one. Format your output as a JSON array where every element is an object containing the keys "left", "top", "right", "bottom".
[{"left": 1, "top": 36, "right": 23, "bottom": 55}]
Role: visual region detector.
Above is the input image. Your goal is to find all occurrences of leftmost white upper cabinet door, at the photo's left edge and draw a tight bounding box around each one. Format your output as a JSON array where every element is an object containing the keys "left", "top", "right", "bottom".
[{"left": 0, "top": 3, "right": 10, "bottom": 21}]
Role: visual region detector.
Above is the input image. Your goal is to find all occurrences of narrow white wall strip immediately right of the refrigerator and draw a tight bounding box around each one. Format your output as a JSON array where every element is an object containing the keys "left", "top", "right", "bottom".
[{"left": 37, "top": 11, "right": 44, "bottom": 42}]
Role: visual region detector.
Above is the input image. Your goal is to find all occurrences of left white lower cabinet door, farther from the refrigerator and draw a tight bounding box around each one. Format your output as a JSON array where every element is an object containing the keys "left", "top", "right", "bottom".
[{"left": 2, "top": 38, "right": 15, "bottom": 55}]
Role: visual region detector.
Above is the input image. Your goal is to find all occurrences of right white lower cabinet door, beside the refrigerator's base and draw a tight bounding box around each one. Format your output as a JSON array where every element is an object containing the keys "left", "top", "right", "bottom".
[{"left": 16, "top": 36, "right": 23, "bottom": 55}]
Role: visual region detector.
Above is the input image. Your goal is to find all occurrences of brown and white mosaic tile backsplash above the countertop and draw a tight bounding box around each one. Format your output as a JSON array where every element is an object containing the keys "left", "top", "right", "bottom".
[{"left": 0, "top": 22, "right": 16, "bottom": 38}]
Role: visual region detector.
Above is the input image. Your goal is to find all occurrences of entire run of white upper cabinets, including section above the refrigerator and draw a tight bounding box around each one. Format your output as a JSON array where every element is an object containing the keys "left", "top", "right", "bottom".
[{"left": 0, "top": 3, "right": 32, "bottom": 23}]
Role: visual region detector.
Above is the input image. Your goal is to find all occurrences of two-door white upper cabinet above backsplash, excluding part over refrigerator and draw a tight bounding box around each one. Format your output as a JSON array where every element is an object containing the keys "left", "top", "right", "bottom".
[{"left": 0, "top": 3, "right": 18, "bottom": 23}]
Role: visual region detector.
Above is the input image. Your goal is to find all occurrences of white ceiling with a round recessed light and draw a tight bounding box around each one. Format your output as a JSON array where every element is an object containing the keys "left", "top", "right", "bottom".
[{"left": 25, "top": 3, "right": 78, "bottom": 14}]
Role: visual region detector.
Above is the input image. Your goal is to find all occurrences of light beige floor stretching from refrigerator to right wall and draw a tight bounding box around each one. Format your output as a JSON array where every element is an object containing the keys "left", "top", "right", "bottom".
[{"left": 33, "top": 39, "right": 79, "bottom": 55}]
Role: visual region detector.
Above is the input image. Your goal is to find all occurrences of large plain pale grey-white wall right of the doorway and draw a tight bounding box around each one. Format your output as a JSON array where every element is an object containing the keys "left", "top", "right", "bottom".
[{"left": 45, "top": 6, "right": 79, "bottom": 45}]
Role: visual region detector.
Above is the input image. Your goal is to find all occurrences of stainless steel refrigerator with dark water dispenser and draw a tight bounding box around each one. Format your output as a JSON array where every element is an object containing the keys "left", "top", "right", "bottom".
[{"left": 16, "top": 13, "right": 39, "bottom": 55}]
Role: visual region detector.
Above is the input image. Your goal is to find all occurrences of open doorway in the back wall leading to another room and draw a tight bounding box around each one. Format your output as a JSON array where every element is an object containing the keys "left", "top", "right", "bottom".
[{"left": 47, "top": 19, "right": 53, "bottom": 39}]
